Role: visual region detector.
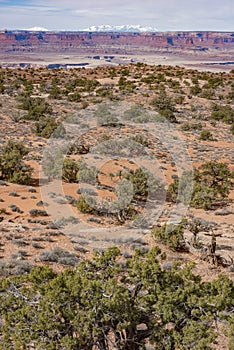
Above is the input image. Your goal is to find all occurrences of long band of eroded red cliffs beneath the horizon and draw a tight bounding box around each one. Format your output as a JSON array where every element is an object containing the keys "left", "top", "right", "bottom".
[{"left": 0, "top": 31, "right": 234, "bottom": 53}]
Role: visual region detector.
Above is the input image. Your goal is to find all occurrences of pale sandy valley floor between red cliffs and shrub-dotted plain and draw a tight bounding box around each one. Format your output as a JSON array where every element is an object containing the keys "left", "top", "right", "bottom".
[{"left": 0, "top": 52, "right": 234, "bottom": 72}]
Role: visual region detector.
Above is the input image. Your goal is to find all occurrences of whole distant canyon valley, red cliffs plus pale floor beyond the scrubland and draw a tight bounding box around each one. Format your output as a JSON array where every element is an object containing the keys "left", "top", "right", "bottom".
[{"left": 0, "top": 30, "right": 234, "bottom": 71}]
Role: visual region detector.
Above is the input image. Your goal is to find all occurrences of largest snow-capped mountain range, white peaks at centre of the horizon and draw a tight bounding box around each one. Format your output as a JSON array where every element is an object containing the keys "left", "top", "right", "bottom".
[{"left": 82, "top": 24, "right": 158, "bottom": 33}]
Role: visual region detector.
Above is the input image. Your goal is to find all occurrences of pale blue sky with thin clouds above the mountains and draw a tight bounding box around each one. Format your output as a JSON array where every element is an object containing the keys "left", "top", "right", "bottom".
[{"left": 0, "top": 0, "right": 234, "bottom": 31}]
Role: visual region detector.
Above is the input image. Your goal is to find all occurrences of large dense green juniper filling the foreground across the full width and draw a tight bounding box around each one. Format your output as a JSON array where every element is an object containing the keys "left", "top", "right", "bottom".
[{"left": 0, "top": 247, "right": 234, "bottom": 350}]
